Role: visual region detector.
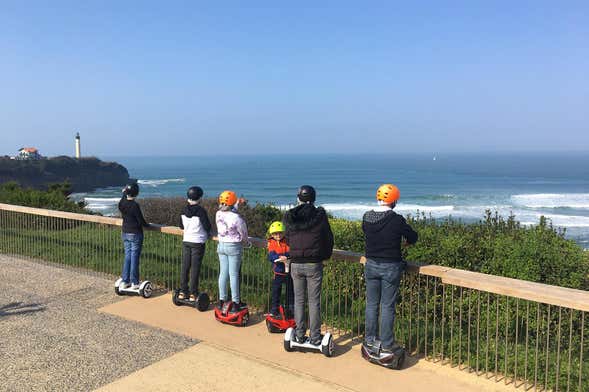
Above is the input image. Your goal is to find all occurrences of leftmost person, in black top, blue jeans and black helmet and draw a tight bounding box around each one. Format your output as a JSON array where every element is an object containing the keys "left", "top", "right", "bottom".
[{"left": 119, "top": 182, "right": 149, "bottom": 289}]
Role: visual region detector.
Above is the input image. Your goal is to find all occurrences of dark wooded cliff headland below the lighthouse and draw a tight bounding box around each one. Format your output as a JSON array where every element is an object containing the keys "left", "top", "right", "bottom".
[{"left": 0, "top": 156, "right": 129, "bottom": 192}]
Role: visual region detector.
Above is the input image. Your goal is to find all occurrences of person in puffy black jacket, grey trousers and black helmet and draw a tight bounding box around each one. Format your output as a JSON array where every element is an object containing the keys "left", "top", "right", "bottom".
[{"left": 284, "top": 185, "right": 333, "bottom": 345}]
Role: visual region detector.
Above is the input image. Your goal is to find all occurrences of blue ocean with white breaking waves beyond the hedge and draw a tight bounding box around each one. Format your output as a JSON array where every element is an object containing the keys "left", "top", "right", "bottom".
[{"left": 72, "top": 153, "right": 589, "bottom": 248}]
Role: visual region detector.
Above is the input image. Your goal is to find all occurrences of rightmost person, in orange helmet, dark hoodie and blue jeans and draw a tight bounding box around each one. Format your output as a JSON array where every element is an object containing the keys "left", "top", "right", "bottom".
[{"left": 362, "top": 184, "right": 417, "bottom": 354}]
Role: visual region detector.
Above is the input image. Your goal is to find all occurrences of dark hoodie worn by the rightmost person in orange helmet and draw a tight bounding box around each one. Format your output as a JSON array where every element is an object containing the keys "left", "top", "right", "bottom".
[{"left": 362, "top": 209, "right": 417, "bottom": 262}]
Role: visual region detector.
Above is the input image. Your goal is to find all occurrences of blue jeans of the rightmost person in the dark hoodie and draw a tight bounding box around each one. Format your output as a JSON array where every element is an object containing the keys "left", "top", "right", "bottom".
[{"left": 364, "top": 259, "right": 406, "bottom": 349}]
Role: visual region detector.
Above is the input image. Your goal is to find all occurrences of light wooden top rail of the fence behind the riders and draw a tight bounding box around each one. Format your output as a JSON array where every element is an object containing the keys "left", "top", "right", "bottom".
[{"left": 0, "top": 203, "right": 589, "bottom": 312}]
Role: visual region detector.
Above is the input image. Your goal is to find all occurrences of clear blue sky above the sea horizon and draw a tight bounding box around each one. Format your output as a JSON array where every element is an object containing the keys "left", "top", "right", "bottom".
[{"left": 0, "top": 1, "right": 589, "bottom": 156}]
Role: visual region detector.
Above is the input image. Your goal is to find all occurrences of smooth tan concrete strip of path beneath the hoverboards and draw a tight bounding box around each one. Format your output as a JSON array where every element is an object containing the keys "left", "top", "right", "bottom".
[{"left": 101, "top": 295, "right": 513, "bottom": 392}]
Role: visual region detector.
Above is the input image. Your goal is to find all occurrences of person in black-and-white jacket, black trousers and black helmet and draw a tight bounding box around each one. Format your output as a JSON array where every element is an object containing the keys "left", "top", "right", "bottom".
[{"left": 178, "top": 186, "right": 211, "bottom": 301}]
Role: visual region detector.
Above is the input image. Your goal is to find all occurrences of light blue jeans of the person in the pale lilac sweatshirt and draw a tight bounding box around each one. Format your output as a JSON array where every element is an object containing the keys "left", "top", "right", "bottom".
[{"left": 217, "top": 242, "right": 243, "bottom": 303}]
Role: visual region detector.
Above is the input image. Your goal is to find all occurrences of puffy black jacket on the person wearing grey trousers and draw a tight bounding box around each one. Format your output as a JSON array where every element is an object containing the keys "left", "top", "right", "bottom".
[{"left": 284, "top": 203, "right": 333, "bottom": 263}]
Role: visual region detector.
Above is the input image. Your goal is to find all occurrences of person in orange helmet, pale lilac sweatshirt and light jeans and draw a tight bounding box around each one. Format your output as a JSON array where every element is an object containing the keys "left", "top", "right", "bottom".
[{"left": 215, "top": 191, "right": 249, "bottom": 313}]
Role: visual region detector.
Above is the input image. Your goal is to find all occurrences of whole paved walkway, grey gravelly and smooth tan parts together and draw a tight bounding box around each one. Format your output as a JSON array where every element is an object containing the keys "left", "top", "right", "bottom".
[{"left": 0, "top": 255, "right": 513, "bottom": 392}]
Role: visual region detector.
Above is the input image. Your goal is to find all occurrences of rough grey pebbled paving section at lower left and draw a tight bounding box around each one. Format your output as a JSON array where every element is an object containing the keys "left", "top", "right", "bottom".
[{"left": 0, "top": 255, "right": 197, "bottom": 391}]
